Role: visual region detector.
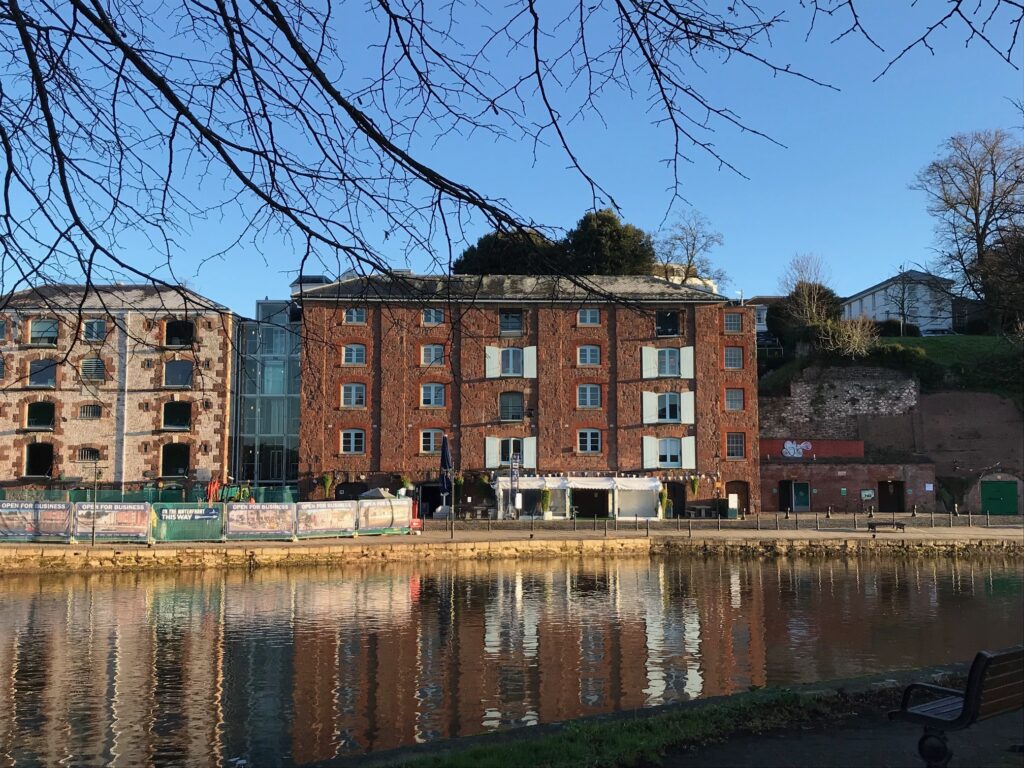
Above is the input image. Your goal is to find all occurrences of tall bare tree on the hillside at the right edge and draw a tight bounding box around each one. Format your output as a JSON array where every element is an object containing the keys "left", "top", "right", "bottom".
[{"left": 911, "top": 130, "right": 1024, "bottom": 324}]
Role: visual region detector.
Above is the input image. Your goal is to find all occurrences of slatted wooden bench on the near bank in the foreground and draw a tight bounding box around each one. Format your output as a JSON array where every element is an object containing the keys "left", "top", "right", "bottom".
[{"left": 889, "top": 645, "right": 1024, "bottom": 768}]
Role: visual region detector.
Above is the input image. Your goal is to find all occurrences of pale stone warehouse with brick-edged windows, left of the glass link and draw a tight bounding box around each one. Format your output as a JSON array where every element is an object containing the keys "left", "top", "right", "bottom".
[{"left": 0, "top": 286, "right": 233, "bottom": 487}]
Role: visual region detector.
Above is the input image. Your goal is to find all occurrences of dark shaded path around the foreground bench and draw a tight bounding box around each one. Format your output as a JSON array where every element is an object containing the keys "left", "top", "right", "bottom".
[{"left": 663, "top": 712, "right": 1024, "bottom": 768}]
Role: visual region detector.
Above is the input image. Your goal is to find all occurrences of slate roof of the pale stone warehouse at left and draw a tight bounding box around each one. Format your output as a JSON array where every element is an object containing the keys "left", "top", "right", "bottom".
[{"left": 0, "top": 284, "right": 230, "bottom": 312}]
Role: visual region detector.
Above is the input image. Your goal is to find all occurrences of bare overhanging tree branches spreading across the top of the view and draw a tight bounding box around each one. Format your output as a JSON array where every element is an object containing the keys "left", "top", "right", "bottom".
[{"left": 0, "top": 0, "right": 1024, "bottom": 307}]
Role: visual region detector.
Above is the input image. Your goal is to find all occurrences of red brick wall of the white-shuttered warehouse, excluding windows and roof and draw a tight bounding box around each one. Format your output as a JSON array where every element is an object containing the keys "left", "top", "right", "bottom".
[{"left": 299, "top": 280, "right": 760, "bottom": 514}]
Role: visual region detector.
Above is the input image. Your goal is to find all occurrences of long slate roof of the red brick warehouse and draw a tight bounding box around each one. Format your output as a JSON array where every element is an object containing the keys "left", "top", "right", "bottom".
[{"left": 292, "top": 273, "right": 727, "bottom": 302}]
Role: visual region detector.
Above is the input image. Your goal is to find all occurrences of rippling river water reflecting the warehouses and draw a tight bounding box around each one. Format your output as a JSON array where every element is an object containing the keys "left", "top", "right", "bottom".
[{"left": 0, "top": 558, "right": 1024, "bottom": 766}]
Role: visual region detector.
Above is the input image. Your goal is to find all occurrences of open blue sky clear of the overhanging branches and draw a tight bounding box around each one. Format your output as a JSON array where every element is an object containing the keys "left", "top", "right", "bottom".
[{"left": 178, "top": 2, "right": 1024, "bottom": 313}]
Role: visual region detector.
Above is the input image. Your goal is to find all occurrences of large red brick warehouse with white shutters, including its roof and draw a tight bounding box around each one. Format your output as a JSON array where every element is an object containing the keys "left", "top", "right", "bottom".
[{"left": 296, "top": 274, "right": 761, "bottom": 515}]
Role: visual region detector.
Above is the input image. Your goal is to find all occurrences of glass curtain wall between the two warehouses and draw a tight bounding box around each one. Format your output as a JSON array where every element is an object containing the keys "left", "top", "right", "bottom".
[{"left": 234, "top": 301, "right": 301, "bottom": 485}]
